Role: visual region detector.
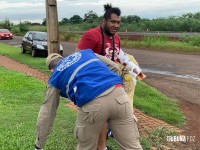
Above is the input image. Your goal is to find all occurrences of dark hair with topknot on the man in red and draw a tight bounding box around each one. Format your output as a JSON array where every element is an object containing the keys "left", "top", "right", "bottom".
[{"left": 103, "top": 4, "right": 121, "bottom": 20}]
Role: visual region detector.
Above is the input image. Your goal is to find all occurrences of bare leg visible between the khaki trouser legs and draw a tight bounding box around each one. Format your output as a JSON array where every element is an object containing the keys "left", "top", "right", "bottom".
[{"left": 97, "top": 122, "right": 108, "bottom": 150}]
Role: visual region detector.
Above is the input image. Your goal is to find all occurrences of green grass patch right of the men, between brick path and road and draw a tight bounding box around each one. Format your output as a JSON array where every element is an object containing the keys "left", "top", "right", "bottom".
[{"left": 134, "top": 81, "right": 184, "bottom": 127}]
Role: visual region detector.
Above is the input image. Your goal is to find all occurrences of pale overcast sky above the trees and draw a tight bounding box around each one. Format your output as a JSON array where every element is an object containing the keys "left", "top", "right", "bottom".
[{"left": 0, "top": 0, "right": 200, "bottom": 22}]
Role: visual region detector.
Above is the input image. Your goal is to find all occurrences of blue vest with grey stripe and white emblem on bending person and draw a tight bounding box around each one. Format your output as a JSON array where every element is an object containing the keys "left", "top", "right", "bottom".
[{"left": 48, "top": 49, "right": 123, "bottom": 107}]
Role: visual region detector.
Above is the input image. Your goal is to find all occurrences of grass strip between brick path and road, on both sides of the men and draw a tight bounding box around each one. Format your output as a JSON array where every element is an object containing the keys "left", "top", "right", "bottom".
[{"left": 0, "top": 44, "right": 184, "bottom": 127}]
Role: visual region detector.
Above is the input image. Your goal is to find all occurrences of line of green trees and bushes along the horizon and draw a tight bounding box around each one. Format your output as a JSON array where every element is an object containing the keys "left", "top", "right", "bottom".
[{"left": 0, "top": 10, "right": 200, "bottom": 32}]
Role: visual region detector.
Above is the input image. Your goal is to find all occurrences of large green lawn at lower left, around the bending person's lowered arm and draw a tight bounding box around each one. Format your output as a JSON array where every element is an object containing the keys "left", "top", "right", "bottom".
[{"left": 0, "top": 67, "right": 76, "bottom": 150}]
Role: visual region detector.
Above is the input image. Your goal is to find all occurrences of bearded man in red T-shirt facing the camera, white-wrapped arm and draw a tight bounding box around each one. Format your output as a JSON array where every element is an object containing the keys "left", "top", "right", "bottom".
[{"left": 76, "top": 4, "right": 145, "bottom": 150}]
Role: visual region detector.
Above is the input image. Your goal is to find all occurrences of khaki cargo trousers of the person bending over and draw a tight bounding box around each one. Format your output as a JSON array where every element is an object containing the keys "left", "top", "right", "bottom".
[{"left": 74, "top": 87, "right": 142, "bottom": 150}]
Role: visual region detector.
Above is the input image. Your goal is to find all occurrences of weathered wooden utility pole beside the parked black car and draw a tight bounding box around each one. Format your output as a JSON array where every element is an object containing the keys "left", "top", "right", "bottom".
[{"left": 46, "top": 0, "right": 60, "bottom": 54}]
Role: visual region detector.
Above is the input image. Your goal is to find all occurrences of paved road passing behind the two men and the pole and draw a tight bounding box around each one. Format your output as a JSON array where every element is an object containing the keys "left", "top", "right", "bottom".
[{"left": 0, "top": 36, "right": 200, "bottom": 105}]
